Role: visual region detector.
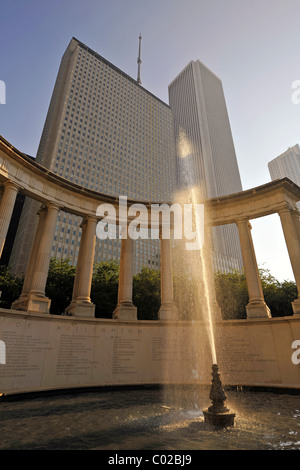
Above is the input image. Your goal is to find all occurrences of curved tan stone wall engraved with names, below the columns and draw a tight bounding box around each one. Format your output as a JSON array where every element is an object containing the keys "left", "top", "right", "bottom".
[{"left": 0, "top": 309, "right": 300, "bottom": 395}]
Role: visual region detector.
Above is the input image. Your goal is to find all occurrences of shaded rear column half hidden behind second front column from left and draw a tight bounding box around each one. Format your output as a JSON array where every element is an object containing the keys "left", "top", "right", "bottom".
[{"left": 11, "top": 206, "right": 47, "bottom": 310}]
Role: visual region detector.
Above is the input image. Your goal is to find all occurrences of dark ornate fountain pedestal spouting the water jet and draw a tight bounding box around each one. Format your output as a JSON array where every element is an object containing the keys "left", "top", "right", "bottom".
[{"left": 203, "top": 364, "right": 235, "bottom": 427}]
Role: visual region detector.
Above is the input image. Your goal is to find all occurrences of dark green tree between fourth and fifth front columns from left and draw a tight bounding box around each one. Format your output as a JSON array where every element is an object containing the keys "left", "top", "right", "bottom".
[{"left": 133, "top": 267, "right": 161, "bottom": 320}]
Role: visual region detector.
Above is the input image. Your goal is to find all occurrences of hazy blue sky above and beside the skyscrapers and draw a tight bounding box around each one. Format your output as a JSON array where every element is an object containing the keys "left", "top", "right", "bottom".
[{"left": 0, "top": 0, "right": 300, "bottom": 280}]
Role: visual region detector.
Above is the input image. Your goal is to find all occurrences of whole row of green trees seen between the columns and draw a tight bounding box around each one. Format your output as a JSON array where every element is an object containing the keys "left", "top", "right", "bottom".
[{"left": 0, "top": 259, "right": 298, "bottom": 321}]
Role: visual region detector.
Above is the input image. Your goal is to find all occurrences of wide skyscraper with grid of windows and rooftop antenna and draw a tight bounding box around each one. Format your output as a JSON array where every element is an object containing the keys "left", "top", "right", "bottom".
[{"left": 10, "top": 38, "right": 176, "bottom": 273}]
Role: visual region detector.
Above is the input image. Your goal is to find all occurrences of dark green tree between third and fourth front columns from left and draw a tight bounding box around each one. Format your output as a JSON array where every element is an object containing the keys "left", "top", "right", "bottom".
[{"left": 91, "top": 261, "right": 119, "bottom": 318}]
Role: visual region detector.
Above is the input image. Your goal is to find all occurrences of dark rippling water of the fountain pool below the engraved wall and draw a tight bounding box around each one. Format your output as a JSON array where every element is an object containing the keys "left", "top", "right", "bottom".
[{"left": 0, "top": 387, "right": 300, "bottom": 455}]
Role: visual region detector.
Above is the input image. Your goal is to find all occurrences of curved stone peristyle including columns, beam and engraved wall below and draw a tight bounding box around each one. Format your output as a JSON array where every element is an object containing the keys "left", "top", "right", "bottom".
[{"left": 0, "top": 137, "right": 300, "bottom": 394}]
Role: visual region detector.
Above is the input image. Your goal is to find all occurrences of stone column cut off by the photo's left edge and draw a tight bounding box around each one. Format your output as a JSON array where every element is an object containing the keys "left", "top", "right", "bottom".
[{"left": 0, "top": 181, "right": 19, "bottom": 257}]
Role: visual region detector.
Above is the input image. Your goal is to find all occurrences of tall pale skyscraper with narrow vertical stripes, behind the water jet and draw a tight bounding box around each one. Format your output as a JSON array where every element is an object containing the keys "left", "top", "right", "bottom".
[{"left": 169, "top": 60, "right": 242, "bottom": 271}]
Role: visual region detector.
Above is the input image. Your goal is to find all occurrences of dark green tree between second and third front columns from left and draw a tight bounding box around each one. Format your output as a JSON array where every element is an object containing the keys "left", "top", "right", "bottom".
[{"left": 45, "top": 258, "right": 76, "bottom": 315}]
